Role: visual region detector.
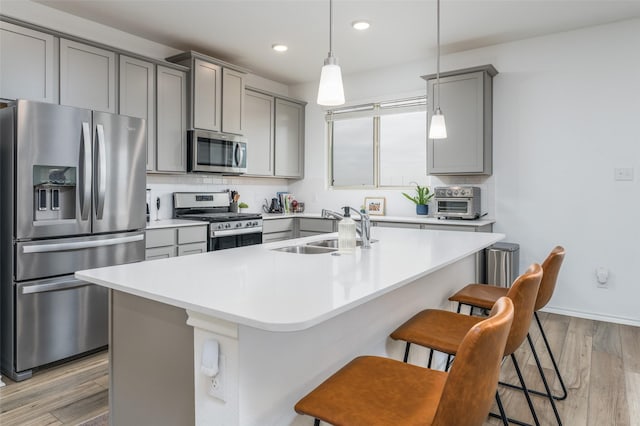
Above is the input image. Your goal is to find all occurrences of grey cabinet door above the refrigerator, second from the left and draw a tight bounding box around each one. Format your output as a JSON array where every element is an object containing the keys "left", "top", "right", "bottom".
[{"left": 60, "top": 39, "right": 116, "bottom": 113}]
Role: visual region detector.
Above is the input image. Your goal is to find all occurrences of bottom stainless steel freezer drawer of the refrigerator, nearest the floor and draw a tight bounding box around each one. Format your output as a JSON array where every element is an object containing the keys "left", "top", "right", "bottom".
[{"left": 15, "top": 275, "right": 108, "bottom": 372}]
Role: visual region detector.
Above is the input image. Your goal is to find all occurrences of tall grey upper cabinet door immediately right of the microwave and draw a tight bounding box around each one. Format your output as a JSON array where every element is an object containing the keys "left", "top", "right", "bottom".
[{"left": 244, "top": 90, "right": 274, "bottom": 176}]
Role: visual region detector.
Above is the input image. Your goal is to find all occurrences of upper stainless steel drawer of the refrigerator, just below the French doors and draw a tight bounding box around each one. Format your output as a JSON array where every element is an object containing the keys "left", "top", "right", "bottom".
[{"left": 15, "top": 231, "right": 144, "bottom": 281}]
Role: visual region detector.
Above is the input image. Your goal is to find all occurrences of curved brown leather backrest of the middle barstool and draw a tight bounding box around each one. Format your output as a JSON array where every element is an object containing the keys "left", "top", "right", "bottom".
[{"left": 504, "top": 263, "right": 542, "bottom": 356}]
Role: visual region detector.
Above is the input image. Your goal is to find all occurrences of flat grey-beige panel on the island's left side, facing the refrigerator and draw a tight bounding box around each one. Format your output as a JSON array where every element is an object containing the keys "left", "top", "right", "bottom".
[{"left": 109, "top": 290, "right": 195, "bottom": 426}]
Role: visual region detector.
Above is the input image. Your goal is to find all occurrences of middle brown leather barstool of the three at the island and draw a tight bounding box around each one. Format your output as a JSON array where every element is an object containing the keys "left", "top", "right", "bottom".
[{"left": 391, "top": 263, "right": 542, "bottom": 425}]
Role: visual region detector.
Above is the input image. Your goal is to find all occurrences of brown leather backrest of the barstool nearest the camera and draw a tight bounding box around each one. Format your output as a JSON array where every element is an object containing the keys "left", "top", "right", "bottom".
[{"left": 432, "top": 297, "right": 514, "bottom": 426}]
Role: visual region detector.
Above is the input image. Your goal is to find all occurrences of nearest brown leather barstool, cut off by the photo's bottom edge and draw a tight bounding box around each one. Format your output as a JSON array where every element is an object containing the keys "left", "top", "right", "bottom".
[{"left": 295, "top": 297, "right": 514, "bottom": 426}]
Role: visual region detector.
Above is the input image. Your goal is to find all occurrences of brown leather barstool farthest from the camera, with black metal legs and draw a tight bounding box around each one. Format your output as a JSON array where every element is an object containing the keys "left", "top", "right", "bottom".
[{"left": 449, "top": 246, "right": 567, "bottom": 400}]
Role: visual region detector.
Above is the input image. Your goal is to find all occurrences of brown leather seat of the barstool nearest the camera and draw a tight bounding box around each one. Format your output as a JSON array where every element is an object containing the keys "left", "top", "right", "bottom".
[{"left": 295, "top": 356, "right": 444, "bottom": 426}]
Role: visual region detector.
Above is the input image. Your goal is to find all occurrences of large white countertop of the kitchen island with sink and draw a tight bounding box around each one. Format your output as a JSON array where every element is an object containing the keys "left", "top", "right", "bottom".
[{"left": 76, "top": 228, "right": 504, "bottom": 331}]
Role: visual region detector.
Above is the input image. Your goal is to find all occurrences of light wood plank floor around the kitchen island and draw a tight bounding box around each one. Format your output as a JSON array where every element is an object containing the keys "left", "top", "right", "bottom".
[{"left": 0, "top": 314, "right": 640, "bottom": 426}]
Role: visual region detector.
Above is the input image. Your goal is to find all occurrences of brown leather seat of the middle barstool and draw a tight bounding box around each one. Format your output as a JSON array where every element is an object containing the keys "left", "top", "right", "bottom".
[{"left": 391, "top": 309, "right": 485, "bottom": 355}]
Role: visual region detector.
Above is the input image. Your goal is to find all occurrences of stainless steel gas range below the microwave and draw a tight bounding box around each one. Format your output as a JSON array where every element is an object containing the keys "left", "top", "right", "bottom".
[{"left": 173, "top": 192, "right": 262, "bottom": 251}]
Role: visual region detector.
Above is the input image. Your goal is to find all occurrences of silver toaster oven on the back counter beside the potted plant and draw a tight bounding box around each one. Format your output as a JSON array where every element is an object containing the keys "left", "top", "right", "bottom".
[{"left": 434, "top": 186, "right": 481, "bottom": 219}]
